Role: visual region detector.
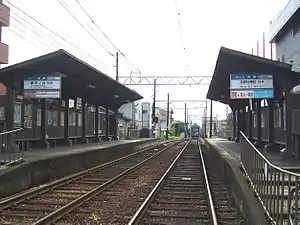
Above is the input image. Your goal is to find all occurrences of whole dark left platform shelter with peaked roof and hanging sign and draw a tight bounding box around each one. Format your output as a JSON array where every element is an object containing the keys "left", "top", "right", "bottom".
[{"left": 0, "top": 50, "right": 142, "bottom": 148}]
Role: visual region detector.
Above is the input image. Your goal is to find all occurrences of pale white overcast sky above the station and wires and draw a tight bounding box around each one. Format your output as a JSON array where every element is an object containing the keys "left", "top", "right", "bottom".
[{"left": 3, "top": 0, "right": 287, "bottom": 122}]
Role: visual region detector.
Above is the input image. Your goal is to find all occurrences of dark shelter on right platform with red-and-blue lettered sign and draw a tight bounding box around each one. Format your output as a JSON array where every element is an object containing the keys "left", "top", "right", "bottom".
[{"left": 207, "top": 47, "right": 300, "bottom": 159}]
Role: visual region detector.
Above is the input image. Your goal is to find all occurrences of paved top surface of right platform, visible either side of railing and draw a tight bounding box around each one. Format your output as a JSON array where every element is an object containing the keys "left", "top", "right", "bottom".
[{"left": 207, "top": 138, "right": 300, "bottom": 169}]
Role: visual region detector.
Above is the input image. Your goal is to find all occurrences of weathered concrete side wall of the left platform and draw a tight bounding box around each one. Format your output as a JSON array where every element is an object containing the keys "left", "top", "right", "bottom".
[{"left": 0, "top": 139, "right": 159, "bottom": 199}]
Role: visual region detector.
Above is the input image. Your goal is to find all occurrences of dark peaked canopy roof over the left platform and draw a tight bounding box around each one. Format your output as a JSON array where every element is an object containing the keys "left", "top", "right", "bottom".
[{"left": 0, "top": 49, "right": 143, "bottom": 111}]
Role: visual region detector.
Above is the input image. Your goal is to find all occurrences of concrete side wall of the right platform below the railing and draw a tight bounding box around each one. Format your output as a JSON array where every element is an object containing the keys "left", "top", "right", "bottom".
[{"left": 204, "top": 139, "right": 271, "bottom": 225}]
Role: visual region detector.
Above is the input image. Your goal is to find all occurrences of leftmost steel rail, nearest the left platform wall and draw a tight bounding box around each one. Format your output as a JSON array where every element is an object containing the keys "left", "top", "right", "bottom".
[{"left": 0, "top": 142, "right": 173, "bottom": 210}]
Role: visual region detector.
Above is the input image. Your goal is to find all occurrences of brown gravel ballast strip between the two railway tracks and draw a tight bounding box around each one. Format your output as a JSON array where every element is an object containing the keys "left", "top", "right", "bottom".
[{"left": 58, "top": 142, "right": 188, "bottom": 225}]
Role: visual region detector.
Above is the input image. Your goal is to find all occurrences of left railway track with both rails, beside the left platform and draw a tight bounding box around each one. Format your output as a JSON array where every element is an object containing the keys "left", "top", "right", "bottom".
[{"left": 0, "top": 142, "right": 178, "bottom": 225}]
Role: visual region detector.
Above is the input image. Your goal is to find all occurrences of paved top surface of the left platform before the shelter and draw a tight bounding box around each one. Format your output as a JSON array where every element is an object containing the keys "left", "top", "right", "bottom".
[{"left": 24, "top": 138, "right": 154, "bottom": 161}]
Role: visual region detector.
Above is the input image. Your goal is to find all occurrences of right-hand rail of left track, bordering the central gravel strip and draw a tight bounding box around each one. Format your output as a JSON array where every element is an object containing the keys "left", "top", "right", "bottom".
[{"left": 33, "top": 142, "right": 185, "bottom": 225}]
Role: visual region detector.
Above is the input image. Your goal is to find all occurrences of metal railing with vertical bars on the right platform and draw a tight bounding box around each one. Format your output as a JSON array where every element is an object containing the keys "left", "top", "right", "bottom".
[{"left": 241, "top": 132, "right": 300, "bottom": 225}]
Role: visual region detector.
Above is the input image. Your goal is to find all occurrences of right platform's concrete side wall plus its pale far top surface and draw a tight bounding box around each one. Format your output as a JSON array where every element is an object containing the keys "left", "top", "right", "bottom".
[{"left": 203, "top": 138, "right": 270, "bottom": 224}]
